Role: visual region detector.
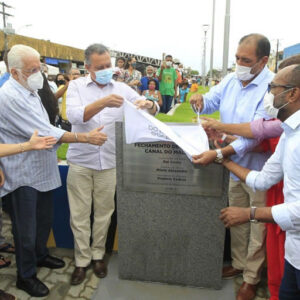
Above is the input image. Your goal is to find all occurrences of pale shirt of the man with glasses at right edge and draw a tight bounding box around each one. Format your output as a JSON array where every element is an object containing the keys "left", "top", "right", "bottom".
[{"left": 246, "top": 110, "right": 300, "bottom": 270}]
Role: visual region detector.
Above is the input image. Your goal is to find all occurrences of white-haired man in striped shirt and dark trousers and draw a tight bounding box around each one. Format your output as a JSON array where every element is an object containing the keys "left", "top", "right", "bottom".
[{"left": 0, "top": 45, "right": 106, "bottom": 297}]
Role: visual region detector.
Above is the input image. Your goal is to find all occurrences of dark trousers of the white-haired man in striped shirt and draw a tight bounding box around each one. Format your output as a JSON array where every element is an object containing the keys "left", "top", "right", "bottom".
[{"left": 3, "top": 186, "right": 53, "bottom": 278}]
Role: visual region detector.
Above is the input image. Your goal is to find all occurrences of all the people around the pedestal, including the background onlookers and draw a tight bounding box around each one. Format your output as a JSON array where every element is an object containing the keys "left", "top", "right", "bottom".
[{"left": 0, "top": 34, "right": 300, "bottom": 300}]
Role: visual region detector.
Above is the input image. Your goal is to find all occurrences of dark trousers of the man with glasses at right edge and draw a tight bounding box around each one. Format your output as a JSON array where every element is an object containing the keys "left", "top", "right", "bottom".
[{"left": 279, "top": 260, "right": 300, "bottom": 300}]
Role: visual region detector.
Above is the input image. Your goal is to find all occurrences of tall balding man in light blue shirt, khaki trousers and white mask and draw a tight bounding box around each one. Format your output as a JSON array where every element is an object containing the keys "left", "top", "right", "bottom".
[{"left": 190, "top": 34, "right": 274, "bottom": 299}]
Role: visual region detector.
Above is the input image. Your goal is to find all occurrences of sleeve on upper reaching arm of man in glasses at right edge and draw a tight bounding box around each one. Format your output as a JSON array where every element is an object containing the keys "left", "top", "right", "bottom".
[{"left": 246, "top": 142, "right": 283, "bottom": 191}]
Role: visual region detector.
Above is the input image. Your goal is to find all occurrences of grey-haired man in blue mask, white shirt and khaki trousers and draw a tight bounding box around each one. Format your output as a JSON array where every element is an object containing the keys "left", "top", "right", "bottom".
[{"left": 67, "top": 44, "right": 159, "bottom": 285}]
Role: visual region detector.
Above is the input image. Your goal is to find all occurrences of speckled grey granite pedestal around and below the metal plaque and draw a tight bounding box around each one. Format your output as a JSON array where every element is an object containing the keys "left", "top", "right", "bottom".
[{"left": 116, "top": 123, "right": 229, "bottom": 289}]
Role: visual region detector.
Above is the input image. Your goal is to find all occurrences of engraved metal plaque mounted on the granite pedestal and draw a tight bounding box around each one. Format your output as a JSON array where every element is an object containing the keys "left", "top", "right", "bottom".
[{"left": 123, "top": 141, "right": 223, "bottom": 196}]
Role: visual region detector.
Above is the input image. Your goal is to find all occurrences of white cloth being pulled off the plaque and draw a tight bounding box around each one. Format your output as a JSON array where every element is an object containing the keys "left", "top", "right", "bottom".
[{"left": 124, "top": 100, "right": 209, "bottom": 160}]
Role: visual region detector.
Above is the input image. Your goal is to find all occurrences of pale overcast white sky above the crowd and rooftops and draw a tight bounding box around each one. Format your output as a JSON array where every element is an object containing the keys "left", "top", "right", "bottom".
[{"left": 0, "top": 0, "right": 300, "bottom": 74}]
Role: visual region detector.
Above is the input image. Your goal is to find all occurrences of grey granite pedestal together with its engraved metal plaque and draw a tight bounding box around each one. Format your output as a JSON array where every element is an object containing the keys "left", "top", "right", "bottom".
[{"left": 116, "top": 123, "right": 229, "bottom": 289}]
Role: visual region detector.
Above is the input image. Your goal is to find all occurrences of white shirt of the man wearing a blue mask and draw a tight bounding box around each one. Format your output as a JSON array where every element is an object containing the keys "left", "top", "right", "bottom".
[{"left": 67, "top": 75, "right": 149, "bottom": 170}]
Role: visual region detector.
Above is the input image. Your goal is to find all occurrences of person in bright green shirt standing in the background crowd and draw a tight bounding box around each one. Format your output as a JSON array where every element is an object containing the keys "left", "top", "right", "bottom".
[{"left": 156, "top": 55, "right": 177, "bottom": 113}]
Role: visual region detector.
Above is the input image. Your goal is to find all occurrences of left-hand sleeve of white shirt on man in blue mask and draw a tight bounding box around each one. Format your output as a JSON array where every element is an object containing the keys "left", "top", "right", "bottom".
[{"left": 67, "top": 81, "right": 86, "bottom": 125}]
